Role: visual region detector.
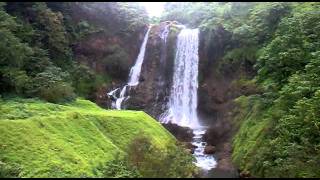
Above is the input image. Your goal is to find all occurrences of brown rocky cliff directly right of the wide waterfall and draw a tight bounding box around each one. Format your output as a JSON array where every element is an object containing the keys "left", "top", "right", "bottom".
[{"left": 198, "top": 27, "right": 253, "bottom": 174}]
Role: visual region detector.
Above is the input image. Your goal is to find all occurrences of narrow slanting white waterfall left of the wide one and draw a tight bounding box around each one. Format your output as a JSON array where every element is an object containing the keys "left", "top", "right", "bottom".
[{"left": 107, "top": 26, "right": 151, "bottom": 110}]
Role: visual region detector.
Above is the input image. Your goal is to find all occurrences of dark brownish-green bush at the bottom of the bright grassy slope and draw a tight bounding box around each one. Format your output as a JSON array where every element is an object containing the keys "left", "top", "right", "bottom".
[{"left": 128, "top": 134, "right": 197, "bottom": 178}]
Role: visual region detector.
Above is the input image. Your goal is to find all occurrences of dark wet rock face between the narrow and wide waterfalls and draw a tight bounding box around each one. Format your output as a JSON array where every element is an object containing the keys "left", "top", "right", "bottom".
[{"left": 112, "top": 22, "right": 179, "bottom": 119}]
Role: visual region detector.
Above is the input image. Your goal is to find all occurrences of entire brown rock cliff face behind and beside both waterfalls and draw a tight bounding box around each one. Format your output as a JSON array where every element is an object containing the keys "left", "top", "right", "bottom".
[{"left": 71, "top": 15, "right": 247, "bottom": 174}]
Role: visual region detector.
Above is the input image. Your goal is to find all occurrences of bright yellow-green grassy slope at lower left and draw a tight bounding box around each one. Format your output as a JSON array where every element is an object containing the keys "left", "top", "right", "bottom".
[{"left": 0, "top": 99, "right": 175, "bottom": 177}]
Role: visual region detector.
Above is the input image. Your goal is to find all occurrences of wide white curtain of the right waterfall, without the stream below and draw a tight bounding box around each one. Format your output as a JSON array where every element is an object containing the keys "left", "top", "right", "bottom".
[{"left": 161, "top": 29, "right": 199, "bottom": 128}]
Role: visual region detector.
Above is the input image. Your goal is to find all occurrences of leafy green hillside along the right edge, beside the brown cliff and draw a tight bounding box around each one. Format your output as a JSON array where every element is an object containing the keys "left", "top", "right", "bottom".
[{"left": 233, "top": 3, "right": 320, "bottom": 178}]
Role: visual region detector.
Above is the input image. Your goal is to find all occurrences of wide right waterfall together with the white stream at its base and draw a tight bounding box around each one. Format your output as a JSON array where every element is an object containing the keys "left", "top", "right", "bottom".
[{"left": 160, "top": 26, "right": 216, "bottom": 170}]
